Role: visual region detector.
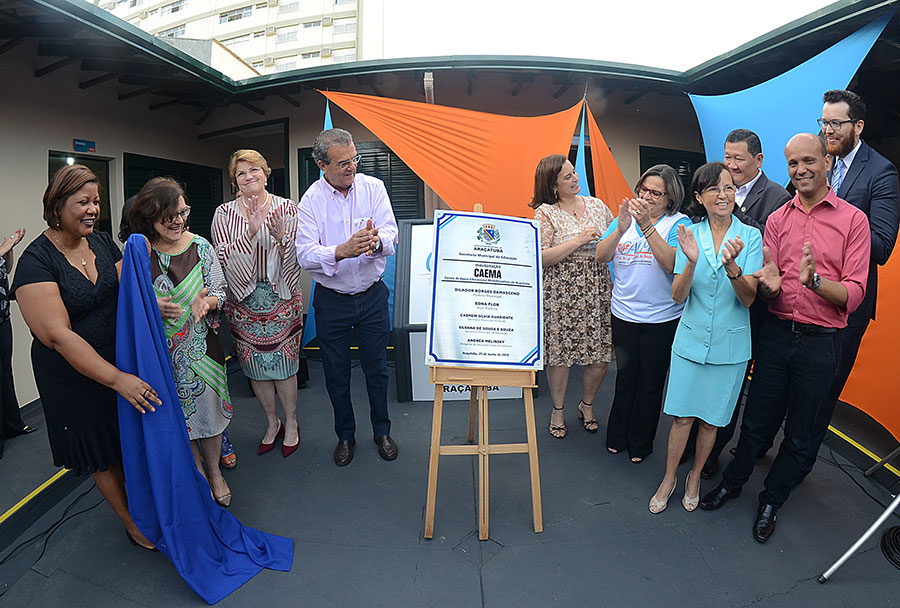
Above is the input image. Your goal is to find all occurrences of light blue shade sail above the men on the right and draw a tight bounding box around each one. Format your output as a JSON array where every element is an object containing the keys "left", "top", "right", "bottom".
[{"left": 690, "top": 13, "right": 893, "bottom": 186}]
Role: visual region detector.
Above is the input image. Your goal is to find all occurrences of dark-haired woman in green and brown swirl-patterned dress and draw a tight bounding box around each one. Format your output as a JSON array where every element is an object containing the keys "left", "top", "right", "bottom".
[{"left": 128, "top": 177, "right": 237, "bottom": 507}]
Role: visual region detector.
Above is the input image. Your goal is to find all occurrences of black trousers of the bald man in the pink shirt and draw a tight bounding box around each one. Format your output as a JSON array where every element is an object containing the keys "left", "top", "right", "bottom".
[{"left": 722, "top": 317, "right": 841, "bottom": 508}]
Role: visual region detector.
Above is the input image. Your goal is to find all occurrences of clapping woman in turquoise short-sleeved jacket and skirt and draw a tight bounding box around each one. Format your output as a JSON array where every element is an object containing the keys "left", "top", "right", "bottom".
[{"left": 650, "top": 162, "right": 762, "bottom": 513}]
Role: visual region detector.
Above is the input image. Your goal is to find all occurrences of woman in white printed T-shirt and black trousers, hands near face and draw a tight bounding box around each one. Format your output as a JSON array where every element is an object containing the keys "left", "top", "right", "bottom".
[{"left": 596, "top": 165, "right": 691, "bottom": 463}]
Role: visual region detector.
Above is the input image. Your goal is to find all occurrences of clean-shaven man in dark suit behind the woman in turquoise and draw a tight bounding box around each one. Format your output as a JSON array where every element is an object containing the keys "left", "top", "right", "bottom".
[{"left": 689, "top": 129, "right": 791, "bottom": 479}]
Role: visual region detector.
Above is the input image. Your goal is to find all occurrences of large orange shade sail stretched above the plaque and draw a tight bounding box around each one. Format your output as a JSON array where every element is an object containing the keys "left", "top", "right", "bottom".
[{"left": 322, "top": 91, "right": 583, "bottom": 217}]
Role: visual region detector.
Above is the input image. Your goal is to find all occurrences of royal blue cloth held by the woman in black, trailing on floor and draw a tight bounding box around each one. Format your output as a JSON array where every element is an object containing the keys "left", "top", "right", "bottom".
[{"left": 116, "top": 235, "right": 294, "bottom": 604}]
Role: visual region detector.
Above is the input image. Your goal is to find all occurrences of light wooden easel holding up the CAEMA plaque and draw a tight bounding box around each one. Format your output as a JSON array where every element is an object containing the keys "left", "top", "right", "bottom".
[{"left": 425, "top": 366, "right": 544, "bottom": 540}]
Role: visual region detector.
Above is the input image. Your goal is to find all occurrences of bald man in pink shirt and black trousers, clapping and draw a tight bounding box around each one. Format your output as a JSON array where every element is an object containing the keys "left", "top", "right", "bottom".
[{"left": 700, "top": 133, "right": 871, "bottom": 543}]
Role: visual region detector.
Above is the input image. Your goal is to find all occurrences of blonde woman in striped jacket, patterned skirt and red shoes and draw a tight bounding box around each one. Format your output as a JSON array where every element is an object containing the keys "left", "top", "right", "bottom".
[{"left": 212, "top": 150, "right": 303, "bottom": 457}]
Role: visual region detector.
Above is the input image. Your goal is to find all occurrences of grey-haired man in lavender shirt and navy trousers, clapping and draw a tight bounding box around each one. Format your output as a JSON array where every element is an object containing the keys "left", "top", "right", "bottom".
[{"left": 296, "top": 129, "right": 398, "bottom": 466}]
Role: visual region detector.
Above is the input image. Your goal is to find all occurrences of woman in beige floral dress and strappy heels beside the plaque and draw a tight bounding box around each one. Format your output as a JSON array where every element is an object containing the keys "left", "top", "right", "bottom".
[{"left": 531, "top": 154, "right": 613, "bottom": 439}]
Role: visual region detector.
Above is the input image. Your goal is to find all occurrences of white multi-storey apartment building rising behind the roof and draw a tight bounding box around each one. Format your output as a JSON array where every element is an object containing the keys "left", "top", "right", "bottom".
[{"left": 95, "top": 0, "right": 361, "bottom": 74}]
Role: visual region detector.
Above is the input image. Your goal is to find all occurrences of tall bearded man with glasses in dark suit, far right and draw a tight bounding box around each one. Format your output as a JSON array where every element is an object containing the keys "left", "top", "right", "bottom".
[{"left": 803, "top": 90, "right": 900, "bottom": 475}]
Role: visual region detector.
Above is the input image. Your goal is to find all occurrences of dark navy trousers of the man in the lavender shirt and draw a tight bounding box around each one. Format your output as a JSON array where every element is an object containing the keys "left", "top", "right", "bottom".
[{"left": 313, "top": 281, "right": 391, "bottom": 441}]
